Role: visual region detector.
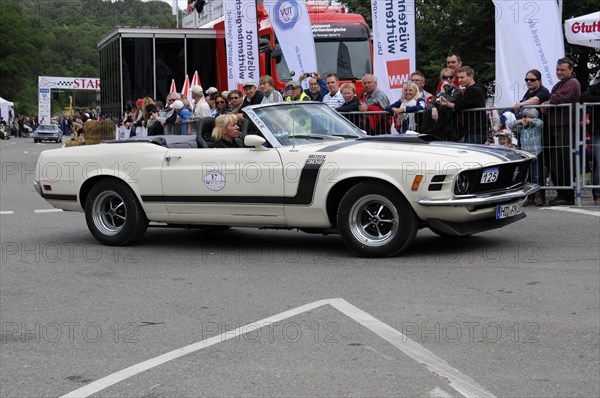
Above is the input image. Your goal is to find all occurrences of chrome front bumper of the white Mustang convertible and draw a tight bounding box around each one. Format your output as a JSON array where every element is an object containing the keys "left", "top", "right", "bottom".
[{"left": 417, "top": 183, "right": 540, "bottom": 207}]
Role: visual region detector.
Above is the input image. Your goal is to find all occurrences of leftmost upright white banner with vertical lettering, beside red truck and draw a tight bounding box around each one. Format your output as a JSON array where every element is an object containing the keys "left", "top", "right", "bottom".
[{"left": 223, "top": 0, "right": 260, "bottom": 90}]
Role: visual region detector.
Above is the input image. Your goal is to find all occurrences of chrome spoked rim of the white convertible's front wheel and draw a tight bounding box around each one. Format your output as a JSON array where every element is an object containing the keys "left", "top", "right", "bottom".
[{"left": 350, "top": 195, "right": 399, "bottom": 247}]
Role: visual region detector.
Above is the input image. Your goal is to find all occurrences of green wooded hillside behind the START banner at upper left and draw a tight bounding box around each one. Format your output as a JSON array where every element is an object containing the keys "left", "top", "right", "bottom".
[{"left": 0, "top": 0, "right": 175, "bottom": 115}]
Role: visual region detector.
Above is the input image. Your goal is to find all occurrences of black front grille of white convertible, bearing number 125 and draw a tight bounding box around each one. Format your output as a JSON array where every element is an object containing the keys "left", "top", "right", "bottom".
[{"left": 454, "top": 160, "right": 531, "bottom": 195}]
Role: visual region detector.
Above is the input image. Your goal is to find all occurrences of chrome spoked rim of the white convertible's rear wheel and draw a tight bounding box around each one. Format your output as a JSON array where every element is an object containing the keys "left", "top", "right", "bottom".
[{"left": 92, "top": 191, "right": 127, "bottom": 236}]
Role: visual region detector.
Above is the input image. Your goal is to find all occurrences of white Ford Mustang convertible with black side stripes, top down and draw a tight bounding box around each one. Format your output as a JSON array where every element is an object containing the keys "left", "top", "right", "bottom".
[{"left": 34, "top": 102, "right": 539, "bottom": 257}]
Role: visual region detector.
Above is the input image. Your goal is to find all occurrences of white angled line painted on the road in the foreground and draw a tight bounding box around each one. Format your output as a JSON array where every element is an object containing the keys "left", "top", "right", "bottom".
[{"left": 61, "top": 298, "right": 494, "bottom": 398}]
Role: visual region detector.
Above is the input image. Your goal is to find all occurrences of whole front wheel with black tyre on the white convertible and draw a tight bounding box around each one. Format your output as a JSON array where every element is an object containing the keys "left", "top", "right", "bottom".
[{"left": 337, "top": 181, "right": 418, "bottom": 257}]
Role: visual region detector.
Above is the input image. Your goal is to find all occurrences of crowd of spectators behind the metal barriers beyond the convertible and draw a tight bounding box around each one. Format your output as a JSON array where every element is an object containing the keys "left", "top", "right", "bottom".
[{"left": 110, "top": 54, "right": 600, "bottom": 206}]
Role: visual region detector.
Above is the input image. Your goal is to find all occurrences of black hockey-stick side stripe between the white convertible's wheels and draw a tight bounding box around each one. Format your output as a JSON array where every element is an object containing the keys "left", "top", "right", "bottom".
[{"left": 142, "top": 163, "right": 323, "bottom": 205}]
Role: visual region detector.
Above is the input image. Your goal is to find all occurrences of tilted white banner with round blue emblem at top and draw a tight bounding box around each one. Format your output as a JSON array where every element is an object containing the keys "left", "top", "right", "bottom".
[{"left": 263, "top": 0, "right": 317, "bottom": 80}]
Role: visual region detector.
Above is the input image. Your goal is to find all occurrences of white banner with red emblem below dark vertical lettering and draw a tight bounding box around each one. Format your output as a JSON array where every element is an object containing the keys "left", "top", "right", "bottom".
[{"left": 371, "top": 0, "right": 417, "bottom": 102}]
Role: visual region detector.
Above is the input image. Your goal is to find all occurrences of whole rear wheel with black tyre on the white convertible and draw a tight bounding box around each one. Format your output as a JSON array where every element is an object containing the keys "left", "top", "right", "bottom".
[{"left": 85, "top": 179, "right": 148, "bottom": 246}]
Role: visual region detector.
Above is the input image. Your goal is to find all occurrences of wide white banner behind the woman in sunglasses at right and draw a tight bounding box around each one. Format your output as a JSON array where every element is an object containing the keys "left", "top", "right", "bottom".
[{"left": 490, "top": 0, "right": 565, "bottom": 107}]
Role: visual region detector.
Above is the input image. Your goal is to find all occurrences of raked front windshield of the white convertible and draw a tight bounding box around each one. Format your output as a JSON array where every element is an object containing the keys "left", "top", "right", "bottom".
[{"left": 253, "top": 103, "right": 364, "bottom": 146}]
